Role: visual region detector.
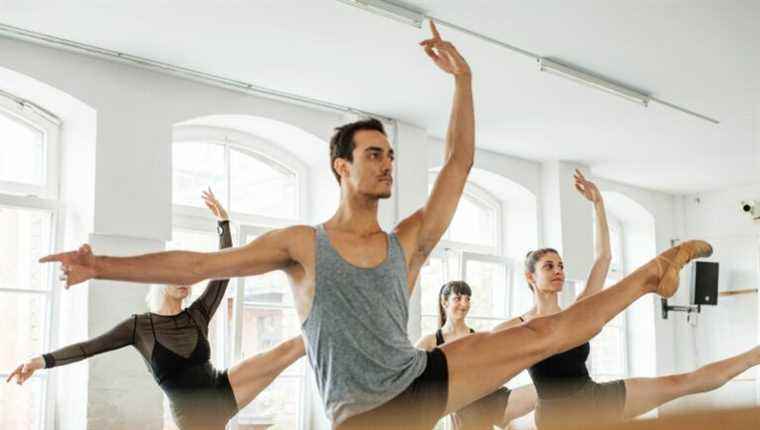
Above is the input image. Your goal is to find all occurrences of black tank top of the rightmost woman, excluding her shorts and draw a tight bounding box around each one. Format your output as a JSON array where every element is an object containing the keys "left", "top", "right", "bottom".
[{"left": 520, "top": 317, "right": 591, "bottom": 399}]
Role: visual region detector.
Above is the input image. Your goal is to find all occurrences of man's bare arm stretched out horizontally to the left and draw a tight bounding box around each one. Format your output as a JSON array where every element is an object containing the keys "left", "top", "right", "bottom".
[{"left": 40, "top": 226, "right": 309, "bottom": 288}]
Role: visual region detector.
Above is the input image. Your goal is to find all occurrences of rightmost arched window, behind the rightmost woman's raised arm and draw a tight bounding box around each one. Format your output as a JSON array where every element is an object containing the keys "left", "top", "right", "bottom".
[{"left": 590, "top": 215, "right": 628, "bottom": 382}]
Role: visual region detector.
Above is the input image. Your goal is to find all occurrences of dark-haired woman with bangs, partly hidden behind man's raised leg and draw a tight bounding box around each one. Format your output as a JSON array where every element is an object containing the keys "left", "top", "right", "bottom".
[{"left": 416, "top": 281, "right": 536, "bottom": 430}]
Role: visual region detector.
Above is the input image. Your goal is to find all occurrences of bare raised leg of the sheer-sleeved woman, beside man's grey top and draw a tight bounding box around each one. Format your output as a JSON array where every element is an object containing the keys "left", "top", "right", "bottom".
[{"left": 227, "top": 336, "right": 305, "bottom": 409}]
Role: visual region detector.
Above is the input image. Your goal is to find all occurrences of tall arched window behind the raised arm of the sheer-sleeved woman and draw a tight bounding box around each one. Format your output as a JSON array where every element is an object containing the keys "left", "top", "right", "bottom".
[{"left": 171, "top": 127, "right": 306, "bottom": 429}]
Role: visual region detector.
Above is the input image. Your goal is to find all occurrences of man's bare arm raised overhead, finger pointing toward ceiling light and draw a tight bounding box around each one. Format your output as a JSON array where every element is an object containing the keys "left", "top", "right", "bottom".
[{"left": 397, "top": 21, "right": 475, "bottom": 278}]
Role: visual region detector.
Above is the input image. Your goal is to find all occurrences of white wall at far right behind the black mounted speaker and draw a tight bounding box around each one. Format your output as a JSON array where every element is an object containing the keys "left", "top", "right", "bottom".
[{"left": 674, "top": 183, "right": 760, "bottom": 408}]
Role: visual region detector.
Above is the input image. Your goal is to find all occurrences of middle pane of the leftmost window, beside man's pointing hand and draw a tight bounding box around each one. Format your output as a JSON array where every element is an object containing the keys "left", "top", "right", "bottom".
[{"left": 0, "top": 208, "right": 51, "bottom": 290}]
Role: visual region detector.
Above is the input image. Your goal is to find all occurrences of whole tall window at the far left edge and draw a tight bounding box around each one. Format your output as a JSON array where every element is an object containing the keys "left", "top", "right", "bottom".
[{"left": 0, "top": 95, "right": 58, "bottom": 429}]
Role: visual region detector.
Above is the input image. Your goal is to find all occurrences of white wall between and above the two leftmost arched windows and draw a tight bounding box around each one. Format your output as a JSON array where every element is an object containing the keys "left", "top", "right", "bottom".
[{"left": 0, "top": 38, "right": 342, "bottom": 429}]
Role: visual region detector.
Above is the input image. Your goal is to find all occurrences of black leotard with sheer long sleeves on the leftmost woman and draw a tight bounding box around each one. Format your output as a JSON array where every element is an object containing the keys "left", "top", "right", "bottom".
[{"left": 43, "top": 221, "right": 237, "bottom": 430}]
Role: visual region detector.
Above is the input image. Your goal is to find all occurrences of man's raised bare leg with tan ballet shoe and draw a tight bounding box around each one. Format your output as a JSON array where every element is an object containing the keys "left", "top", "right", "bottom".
[{"left": 441, "top": 242, "right": 712, "bottom": 414}]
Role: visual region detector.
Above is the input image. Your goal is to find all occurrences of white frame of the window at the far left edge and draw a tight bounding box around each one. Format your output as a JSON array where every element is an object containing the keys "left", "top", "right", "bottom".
[{"left": 0, "top": 92, "right": 63, "bottom": 430}]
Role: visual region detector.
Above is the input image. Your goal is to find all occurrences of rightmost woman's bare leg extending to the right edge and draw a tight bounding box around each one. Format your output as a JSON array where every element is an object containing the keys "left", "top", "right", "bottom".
[{"left": 623, "top": 347, "right": 760, "bottom": 418}]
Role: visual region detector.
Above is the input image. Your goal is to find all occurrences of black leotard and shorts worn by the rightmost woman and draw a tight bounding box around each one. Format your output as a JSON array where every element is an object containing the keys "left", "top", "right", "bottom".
[{"left": 520, "top": 317, "right": 625, "bottom": 429}]
